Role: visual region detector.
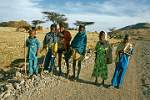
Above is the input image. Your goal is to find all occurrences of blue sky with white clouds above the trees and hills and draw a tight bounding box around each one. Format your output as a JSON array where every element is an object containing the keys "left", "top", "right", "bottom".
[{"left": 0, "top": 0, "right": 150, "bottom": 31}]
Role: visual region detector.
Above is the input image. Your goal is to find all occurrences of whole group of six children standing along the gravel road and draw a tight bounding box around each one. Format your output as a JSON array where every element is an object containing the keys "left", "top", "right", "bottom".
[{"left": 26, "top": 23, "right": 133, "bottom": 88}]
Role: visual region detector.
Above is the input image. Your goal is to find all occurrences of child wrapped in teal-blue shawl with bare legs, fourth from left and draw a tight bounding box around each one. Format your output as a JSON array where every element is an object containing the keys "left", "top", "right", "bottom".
[{"left": 71, "top": 25, "right": 87, "bottom": 80}]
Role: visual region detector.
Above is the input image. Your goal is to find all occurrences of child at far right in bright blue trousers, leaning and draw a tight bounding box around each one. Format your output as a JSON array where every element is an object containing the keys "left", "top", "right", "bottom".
[{"left": 112, "top": 35, "right": 133, "bottom": 88}]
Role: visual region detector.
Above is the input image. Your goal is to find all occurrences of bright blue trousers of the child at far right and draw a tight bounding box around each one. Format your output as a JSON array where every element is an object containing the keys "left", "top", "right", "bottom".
[{"left": 112, "top": 53, "right": 129, "bottom": 86}]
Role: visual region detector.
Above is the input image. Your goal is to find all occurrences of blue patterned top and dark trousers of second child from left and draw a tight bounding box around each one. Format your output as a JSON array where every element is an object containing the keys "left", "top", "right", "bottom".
[{"left": 43, "top": 32, "right": 58, "bottom": 71}]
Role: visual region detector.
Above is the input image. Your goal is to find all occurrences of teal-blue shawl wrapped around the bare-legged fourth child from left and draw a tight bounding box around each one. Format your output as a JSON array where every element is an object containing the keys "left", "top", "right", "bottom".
[{"left": 71, "top": 32, "right": 87, "bottom": 55}]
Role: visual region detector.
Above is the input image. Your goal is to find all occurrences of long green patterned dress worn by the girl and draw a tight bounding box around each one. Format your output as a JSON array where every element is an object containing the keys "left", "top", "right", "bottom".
[{"left": 92, "top": 41, "right": 108, "bottom": 80}]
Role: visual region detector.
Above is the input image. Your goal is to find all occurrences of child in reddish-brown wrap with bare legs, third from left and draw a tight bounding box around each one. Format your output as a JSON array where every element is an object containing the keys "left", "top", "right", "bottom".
[{"left": 58, "top": 23, "right": 72, "bottom": 78}]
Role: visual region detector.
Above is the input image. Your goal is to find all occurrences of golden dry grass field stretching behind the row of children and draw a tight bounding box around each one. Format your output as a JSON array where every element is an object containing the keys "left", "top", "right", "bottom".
[{"left": 0, "top": 27, "right": 119, "bottom": 68}]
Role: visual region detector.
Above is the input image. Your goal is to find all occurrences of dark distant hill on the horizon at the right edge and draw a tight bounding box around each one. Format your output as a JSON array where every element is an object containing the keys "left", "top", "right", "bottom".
[{"left": 119, "top": 23, "right": 150, "bottom": 30}]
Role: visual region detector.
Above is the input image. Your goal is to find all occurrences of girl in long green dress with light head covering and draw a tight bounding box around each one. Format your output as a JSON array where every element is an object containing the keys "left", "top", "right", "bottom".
[{"left": 92, "top": 31, "right": 109, "bottom": 85}]
